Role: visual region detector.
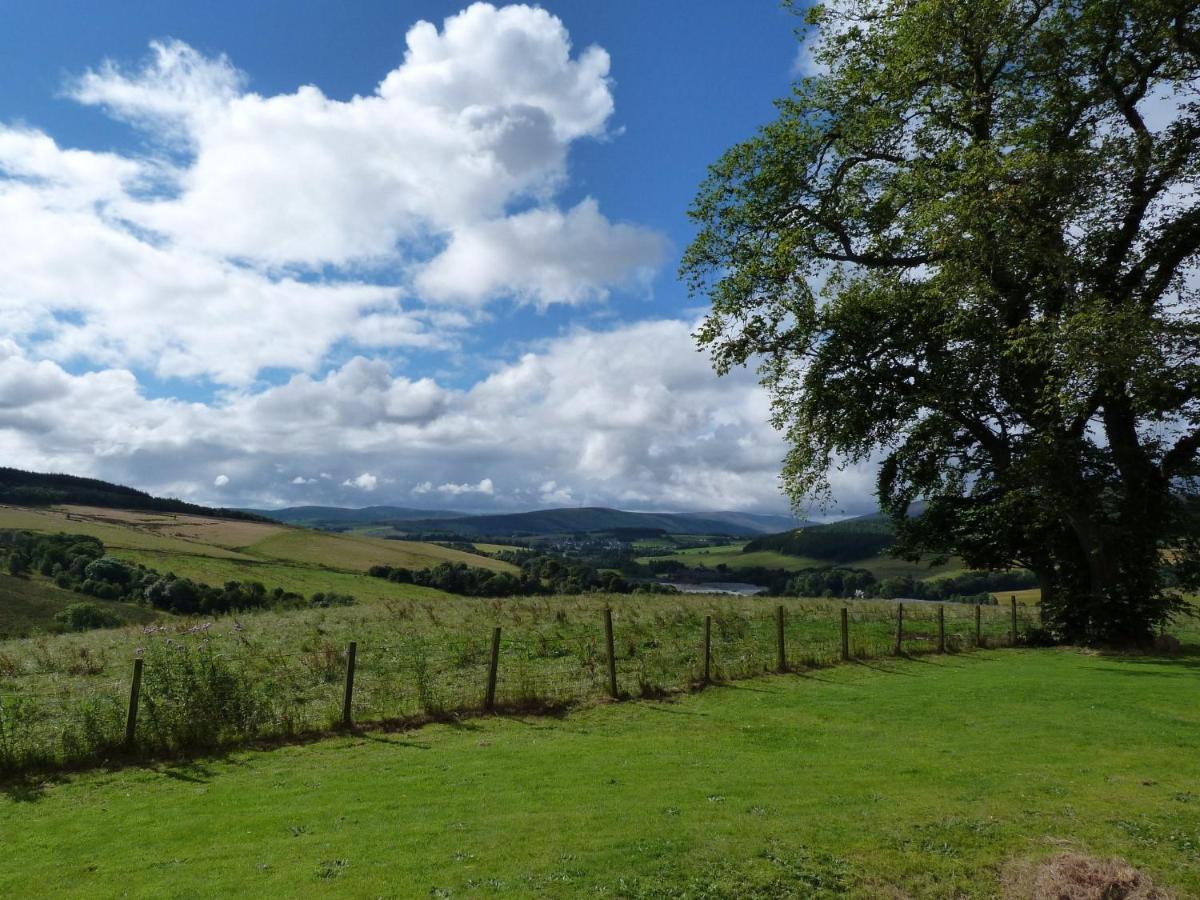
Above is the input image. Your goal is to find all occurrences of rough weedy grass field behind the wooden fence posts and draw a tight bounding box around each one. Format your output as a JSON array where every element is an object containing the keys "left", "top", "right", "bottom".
[{"left": 0, "top": 595, "right": 1032, "bottom": 770}]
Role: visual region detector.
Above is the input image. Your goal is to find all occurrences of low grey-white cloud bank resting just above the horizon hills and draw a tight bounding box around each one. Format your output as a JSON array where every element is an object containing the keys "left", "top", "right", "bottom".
[{"left": 0, "top": 319, "right": 883, "bottom": 510}]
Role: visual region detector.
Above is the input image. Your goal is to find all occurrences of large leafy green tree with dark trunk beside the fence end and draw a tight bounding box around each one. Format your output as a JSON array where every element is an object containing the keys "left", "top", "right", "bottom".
[{"left": 683, "top": 0, "right": 1200, "bottom": 642}]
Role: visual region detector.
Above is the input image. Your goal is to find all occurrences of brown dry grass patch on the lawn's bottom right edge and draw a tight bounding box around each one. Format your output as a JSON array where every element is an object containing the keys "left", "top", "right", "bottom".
[{"left": 1004, "top": 853, "right": 1172, "bottom": 900}]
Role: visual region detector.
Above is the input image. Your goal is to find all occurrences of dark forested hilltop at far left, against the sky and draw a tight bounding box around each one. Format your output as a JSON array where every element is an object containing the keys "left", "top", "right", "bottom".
[{"left": 0, "top": 467, "right": 262, "bottom": 520}]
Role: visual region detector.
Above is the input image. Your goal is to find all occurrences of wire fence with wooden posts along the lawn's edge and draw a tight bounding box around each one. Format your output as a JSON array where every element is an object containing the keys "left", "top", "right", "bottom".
[{"left": 0, "top": 600, "right": 1038, "bottom": 774}]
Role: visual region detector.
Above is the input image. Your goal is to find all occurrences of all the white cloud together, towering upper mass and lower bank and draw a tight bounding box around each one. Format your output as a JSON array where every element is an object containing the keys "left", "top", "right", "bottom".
[{"left": 0, "top": 4, "right": 873, "bottom": 510}]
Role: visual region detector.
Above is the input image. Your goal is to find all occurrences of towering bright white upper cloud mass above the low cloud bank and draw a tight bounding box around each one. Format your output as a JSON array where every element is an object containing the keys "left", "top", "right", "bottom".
[{"left": 0, "top": 4, "right": 664, "bottom": 385}]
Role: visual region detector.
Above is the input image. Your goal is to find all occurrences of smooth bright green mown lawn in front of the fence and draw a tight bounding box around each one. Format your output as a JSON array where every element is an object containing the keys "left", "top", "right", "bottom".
[{"left": 0, "top": 650, "right": 1200, "bottom": 898}]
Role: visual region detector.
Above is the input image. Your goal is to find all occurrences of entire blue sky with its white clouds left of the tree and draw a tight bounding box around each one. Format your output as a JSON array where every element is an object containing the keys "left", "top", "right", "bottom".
[{"left": 0, "top": 0, "right": 866, "bottom": 510}]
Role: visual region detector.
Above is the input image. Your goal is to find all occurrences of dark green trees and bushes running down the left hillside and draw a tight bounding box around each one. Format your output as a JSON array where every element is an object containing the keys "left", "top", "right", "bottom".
[{"left": 0, "top": 532, "right": 354, "bottom": 626}]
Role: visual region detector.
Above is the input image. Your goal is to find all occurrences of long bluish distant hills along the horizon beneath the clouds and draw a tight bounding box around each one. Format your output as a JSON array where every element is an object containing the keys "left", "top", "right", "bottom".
[{"left": 251, "top": 506, "right": 798, "bottom": 538}]
